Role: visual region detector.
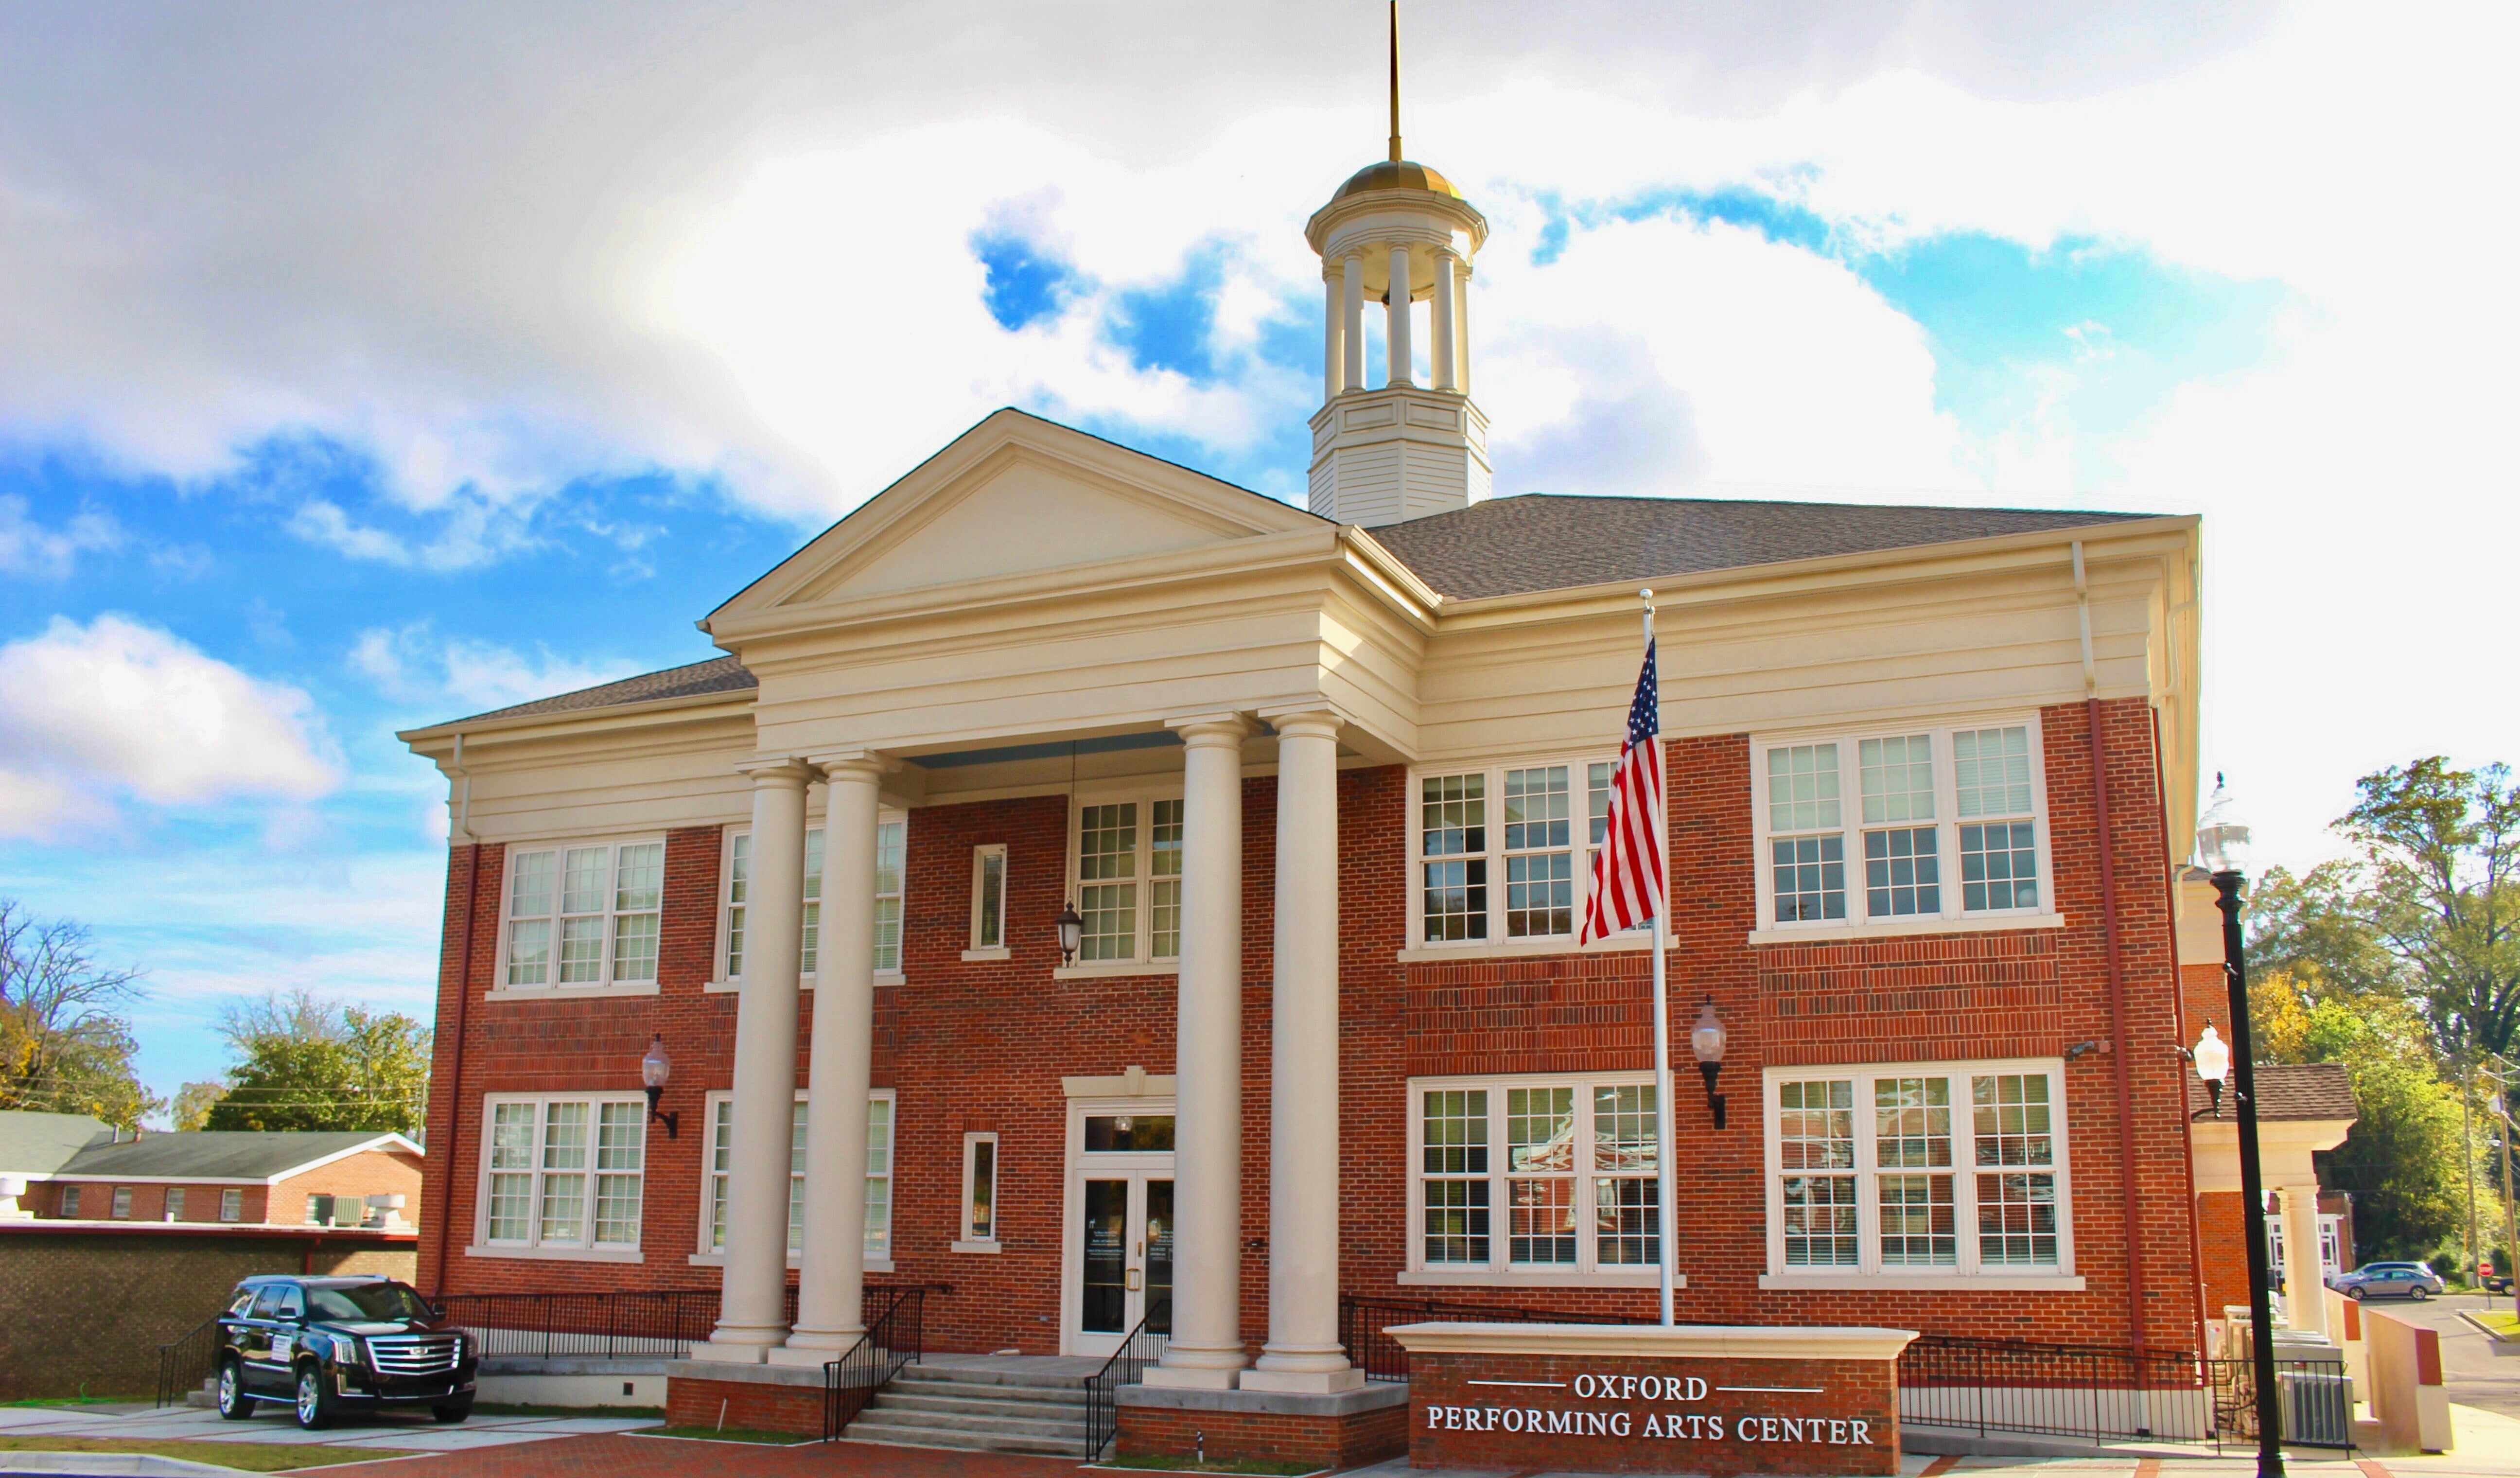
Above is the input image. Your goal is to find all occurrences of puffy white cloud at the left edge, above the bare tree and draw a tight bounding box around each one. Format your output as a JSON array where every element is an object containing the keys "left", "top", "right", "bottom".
[{"left": 0, "top": 616, "right": 340, "bottom": 837}]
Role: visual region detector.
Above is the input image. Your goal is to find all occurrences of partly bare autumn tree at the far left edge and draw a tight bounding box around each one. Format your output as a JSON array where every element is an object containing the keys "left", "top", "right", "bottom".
[{"left": 0, "top": 898, "right": 166, "bottom": 1127}]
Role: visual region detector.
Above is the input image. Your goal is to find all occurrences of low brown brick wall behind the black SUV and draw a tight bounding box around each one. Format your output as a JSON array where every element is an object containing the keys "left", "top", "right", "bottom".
[{"left": 0, "top": 1231, "right": 413, "bottom": 1400}]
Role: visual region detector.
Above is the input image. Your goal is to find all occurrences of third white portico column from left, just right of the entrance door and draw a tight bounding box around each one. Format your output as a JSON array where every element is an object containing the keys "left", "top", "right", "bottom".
[{"left": 1144, "top": 714, "right": 1250, "bottom": 1390}]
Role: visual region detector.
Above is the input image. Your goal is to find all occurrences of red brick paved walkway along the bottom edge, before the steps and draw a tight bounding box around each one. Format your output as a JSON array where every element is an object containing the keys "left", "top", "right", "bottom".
[{"left": 323, "top": 1435, "right": 1079, "bottom": 1478}]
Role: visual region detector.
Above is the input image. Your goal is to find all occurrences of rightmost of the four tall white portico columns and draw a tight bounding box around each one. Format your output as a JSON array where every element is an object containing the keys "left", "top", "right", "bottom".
[{"left": 1242, "top": 711, "right": 1366, "bottom": 1392}]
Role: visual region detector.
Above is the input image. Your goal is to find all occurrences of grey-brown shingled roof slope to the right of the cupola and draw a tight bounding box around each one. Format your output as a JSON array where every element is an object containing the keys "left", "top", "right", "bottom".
[{"left": 1373, "top": 492, "right": 2152, "bottom": 600}]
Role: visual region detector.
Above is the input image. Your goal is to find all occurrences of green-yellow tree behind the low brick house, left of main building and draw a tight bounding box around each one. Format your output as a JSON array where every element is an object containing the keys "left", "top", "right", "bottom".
[{"left": 204, "top": 989, "right": 428, "bottom": 1135}]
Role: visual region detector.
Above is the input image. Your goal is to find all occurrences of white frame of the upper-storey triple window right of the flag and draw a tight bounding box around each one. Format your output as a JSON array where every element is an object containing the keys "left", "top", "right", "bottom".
[{"left": 1749, "top": 711, "right": 2066, "bottom": 946}]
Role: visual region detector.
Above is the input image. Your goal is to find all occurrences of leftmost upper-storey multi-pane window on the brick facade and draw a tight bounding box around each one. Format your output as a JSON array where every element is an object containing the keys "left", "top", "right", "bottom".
[{"left": 504, "top": 843, "right": 665, "bottom": 991}]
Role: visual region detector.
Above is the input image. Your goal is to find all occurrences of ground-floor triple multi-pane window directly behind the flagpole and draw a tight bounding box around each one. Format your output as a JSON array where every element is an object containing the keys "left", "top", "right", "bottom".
[{"left": 1411, "top": 1079, "right": 1663, "bottom": 1274}]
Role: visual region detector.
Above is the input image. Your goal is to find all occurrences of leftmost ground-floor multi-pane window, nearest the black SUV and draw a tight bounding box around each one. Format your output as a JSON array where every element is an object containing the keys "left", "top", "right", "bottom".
[{"left": 476, "top": 1097, "right": 648, "bottom": 1251}]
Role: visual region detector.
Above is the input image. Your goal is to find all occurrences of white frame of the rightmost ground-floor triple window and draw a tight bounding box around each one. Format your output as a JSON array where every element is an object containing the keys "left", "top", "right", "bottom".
[{"left": 1759, "top": 1057, "right": 2084, "bottom": 1294}]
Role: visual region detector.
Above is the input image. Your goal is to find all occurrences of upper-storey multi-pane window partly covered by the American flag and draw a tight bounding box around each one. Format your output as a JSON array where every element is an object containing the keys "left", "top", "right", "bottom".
[{"left": 1411, "top": 759, "right": 1613, "bottom": 943}]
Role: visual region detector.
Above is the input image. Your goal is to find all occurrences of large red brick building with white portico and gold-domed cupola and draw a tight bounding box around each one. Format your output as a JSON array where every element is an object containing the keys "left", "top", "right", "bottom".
[{"left": 403, "top": 129, "right": 2203, "bottom": 1422}]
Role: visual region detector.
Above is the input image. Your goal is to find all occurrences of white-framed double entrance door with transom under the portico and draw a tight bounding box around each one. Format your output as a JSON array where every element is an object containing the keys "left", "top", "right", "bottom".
[{"left": 1058, "top": 1100, "right": 1172, "bottom": 1355}]
